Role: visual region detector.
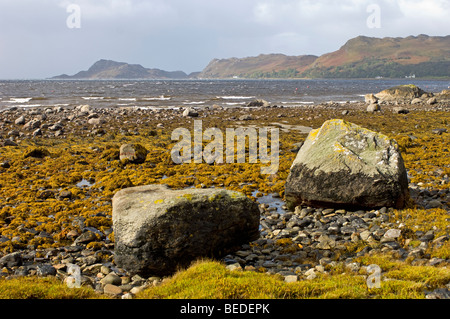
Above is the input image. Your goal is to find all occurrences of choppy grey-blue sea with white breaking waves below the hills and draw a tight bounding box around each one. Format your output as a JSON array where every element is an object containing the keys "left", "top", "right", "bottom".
[{"left": 0, "top": 79, "right": 450, "bottom": 111}]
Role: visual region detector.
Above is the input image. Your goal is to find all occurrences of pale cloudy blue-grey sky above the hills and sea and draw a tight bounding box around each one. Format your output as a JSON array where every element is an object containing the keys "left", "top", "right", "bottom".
[{"left": 0, "top": 0, "right": 450, "bottom": 79}]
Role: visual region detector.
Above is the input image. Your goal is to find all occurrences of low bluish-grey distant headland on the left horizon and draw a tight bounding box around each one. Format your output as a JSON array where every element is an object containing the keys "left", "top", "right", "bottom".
[{"left": 52, "top": 59, "right": 188, "bottom": 79}]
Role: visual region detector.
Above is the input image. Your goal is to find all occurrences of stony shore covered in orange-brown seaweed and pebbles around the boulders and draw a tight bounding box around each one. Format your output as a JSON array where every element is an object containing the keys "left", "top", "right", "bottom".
[{"left": 0, "top": 88, "right": 450, "bottom": 298}]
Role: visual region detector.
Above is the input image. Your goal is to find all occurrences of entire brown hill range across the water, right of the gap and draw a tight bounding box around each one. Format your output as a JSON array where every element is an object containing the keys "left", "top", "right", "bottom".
[{"left": 198, "top": 35, "right": 450, "bottom": 78}]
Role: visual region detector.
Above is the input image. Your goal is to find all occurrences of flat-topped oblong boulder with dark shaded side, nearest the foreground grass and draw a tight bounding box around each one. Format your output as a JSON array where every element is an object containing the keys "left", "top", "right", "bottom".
[{"left": 112, "top": 185, "right": 260, "bottom": 276}]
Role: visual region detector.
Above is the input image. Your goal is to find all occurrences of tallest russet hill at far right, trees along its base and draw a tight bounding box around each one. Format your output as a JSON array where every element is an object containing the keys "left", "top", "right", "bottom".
[{"left": 302, "top": 35, "right": 450, "bottom": 78}]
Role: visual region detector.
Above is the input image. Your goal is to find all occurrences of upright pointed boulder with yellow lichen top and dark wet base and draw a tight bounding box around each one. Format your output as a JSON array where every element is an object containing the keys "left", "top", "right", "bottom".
[{"left": 285, "top": 120, "right": 409, "bottom": 209}]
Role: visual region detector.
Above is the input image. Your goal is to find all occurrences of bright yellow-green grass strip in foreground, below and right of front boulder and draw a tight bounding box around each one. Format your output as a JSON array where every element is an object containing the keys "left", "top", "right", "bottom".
[{"left": 137, "top": 257, "right": 440, "bottom": 299}]
